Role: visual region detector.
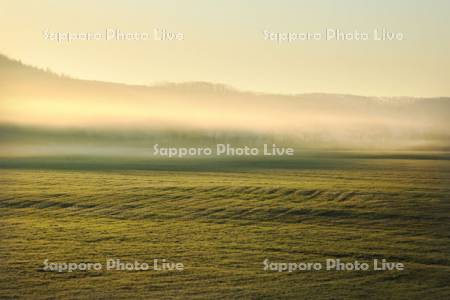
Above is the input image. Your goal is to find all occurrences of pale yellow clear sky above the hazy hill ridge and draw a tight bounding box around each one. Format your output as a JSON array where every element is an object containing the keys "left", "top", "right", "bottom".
[{"left": 0, "top": 0, "right": 450, "bottom": 97}]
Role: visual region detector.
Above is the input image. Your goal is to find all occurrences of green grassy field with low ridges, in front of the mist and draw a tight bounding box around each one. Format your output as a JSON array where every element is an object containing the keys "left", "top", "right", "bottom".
[{"left": 0, "top": 158, "right": 450, "bottom": 299}]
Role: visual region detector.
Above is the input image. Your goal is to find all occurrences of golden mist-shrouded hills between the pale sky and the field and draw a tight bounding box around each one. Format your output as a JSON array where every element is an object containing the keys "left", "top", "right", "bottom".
[{"left": 0, "top": 56, "right": 450, "bottom": 152}]
